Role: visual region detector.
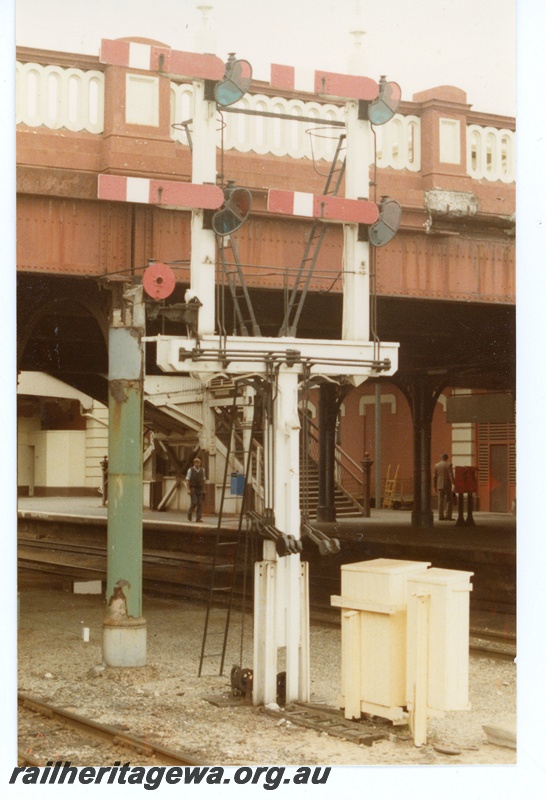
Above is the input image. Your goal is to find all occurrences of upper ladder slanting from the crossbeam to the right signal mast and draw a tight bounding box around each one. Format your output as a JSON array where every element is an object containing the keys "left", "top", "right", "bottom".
[{"left": 278, "top": 134, "right": 346, "bottom": 336}]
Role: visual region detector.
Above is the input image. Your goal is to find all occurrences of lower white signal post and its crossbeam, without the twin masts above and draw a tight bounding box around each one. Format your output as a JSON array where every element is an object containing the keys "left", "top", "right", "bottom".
[{"left": 156, "top": 334, "right": 398, "bottom": 705}]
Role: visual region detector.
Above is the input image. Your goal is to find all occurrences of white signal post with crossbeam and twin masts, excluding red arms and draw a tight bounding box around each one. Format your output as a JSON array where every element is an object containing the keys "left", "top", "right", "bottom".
[{"left": 157, "top": 62, "right": 398, "bottom": 705}]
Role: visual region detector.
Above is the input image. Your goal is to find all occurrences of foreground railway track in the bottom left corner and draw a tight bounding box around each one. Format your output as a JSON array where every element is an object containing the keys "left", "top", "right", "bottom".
[{"left": 17, "top": 694, "right": 202, "bottom": 767}]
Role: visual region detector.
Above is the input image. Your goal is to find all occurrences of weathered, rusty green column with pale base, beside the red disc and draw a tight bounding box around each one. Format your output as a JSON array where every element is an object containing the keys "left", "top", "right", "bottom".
[{"left": 103, "top": 286, "right": 146, "bottom": 667}]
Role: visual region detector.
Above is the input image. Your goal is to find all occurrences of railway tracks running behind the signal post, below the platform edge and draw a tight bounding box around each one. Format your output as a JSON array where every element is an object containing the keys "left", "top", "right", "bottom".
[{"left": 18, "top": 536, "right": 516, "bottom": 660}]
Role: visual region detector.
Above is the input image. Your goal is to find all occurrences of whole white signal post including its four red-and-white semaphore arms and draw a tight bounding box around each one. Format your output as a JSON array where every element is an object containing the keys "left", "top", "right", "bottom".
[{"left": 94, "top": 47, "right": 398, "bottom": 704}]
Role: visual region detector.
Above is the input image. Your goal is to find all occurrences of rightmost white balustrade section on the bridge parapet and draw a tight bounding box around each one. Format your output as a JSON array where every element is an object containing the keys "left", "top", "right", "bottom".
[{"left": 466, "top": 125, "right": 516, "bottom": 183}]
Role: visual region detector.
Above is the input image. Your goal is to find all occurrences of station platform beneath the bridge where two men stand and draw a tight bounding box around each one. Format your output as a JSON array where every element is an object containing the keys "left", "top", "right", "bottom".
[{"left": 18, "top": 496, "right": 510, "bottom": 632}]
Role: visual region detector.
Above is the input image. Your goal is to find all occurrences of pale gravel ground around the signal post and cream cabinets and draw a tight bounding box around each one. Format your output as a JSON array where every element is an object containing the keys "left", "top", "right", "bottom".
[{"left": 18, "top": 588, "right": 516, "bottom": 765}]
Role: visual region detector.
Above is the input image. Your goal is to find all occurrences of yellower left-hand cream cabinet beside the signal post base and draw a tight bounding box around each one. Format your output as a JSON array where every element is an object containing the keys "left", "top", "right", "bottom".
[{"left": 331, "top": 558, "right": 430, "bottom": 722}]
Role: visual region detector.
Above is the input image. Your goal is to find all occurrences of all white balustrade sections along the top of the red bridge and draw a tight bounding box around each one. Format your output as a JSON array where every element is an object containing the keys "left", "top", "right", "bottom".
[{"left": 16, "top": 62, "right": 516, "bottom": 183}]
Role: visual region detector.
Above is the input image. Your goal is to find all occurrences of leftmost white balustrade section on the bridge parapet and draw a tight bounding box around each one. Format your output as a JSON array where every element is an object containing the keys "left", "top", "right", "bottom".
[{"left": 16, "top": 62, "right": 104, "bottom": 133}]
